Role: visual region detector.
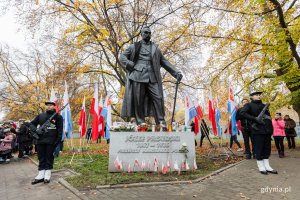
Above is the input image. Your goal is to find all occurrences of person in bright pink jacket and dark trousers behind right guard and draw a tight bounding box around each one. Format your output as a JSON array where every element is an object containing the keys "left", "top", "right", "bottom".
[{"left": 272, "top": 112, "right": 285, "bottom": 158}]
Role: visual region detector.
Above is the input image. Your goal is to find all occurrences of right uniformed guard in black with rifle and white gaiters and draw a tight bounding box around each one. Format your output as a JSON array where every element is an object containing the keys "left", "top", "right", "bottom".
[{"left": 240, "top": 92, "right": 278, "bottom": 175}]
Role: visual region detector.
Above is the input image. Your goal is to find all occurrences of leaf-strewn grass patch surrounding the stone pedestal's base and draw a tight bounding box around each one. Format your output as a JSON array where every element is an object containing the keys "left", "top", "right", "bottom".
[{"left": 35, "top": 140, "right": 240, "bottom": 189}]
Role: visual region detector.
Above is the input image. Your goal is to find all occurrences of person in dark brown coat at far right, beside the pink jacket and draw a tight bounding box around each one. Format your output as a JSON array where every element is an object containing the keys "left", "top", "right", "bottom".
[{"left": 284, "top": 115, "right": 297, "bottom": 149}]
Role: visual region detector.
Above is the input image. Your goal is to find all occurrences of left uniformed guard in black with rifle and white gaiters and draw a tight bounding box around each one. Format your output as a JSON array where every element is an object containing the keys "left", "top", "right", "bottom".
[{"left": 30, "top": 101, "right": 63, "bottom": 184}]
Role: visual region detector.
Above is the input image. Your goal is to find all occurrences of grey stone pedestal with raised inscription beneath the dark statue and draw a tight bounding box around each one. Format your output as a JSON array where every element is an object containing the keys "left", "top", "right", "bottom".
[{"left": 108, "top": 132, "right": 195, "bottom": 172}]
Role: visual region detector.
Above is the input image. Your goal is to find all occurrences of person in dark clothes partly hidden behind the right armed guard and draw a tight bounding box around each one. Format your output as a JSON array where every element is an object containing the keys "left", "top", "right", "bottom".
[{"left": 236, "top": 98, "right": 255, "bottom": 159}]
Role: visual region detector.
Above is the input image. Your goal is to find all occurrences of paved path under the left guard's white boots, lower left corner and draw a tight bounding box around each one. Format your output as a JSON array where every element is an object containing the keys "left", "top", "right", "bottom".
[{"left": 0, "top": 158, "right": 79, "bottom": 200}]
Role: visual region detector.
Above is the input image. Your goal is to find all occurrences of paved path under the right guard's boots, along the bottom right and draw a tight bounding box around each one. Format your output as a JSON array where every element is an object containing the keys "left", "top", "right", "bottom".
[{"left": 85, "top": 149, "right": 300, "bottom": 200}]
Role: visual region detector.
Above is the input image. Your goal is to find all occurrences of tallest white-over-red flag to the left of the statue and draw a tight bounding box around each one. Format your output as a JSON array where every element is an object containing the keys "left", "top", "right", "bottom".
[{"left": 90, "top": 84, "right": 99, "bottom": 140}]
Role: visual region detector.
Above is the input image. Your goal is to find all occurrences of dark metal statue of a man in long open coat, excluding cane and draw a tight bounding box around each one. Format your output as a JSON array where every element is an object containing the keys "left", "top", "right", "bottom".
[{"left": 120, "top": 27, "right": 182, "bottom": 126}]
